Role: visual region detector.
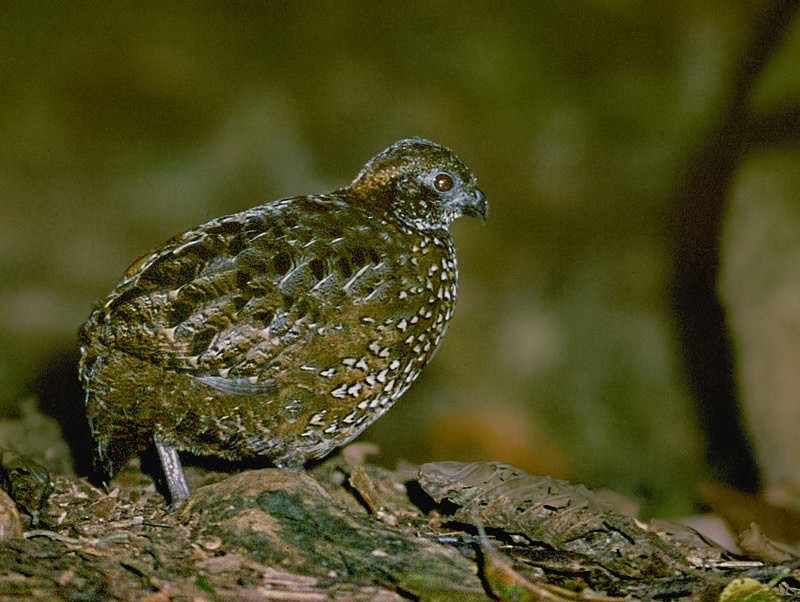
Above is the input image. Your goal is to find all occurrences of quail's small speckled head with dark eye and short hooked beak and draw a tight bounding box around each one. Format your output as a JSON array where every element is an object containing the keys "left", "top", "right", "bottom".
[{"left": 348, "top": 138, "right": 489, "bottom": 229}]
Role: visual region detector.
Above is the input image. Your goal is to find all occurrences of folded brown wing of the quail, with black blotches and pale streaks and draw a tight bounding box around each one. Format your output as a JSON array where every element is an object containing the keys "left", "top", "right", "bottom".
[{"left": 84, "top": 197, "right": 406, "bottom": 386}]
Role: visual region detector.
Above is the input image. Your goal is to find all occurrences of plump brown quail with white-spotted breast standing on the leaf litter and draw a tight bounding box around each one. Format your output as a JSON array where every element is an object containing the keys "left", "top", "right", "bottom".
[{"left": 78, "top": 138, "right": 488, "bottom": 504}]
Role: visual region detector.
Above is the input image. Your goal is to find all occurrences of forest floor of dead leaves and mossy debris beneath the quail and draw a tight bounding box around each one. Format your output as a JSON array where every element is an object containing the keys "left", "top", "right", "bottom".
[{"left": 0, "top": 398, "right": 800, "bottom": 602}]
